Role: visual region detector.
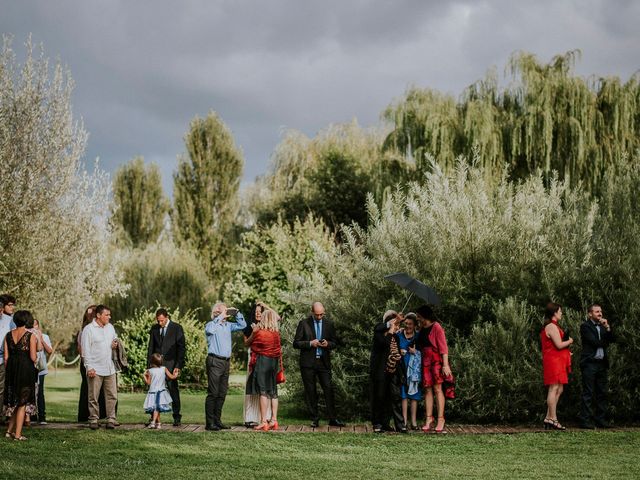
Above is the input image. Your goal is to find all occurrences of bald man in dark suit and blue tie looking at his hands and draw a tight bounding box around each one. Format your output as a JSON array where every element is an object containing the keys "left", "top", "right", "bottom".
[{"left": 293, "top": 302, "right": 344, "bottom": 427}]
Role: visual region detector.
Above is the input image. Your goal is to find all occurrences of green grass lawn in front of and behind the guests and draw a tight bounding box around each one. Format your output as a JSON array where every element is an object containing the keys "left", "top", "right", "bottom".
[{"left": 0, "top": 371, "right": 640, "bottom": 480}]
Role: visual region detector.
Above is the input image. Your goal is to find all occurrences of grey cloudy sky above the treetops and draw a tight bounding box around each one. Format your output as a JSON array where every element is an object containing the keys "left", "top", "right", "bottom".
[{"left": 0, "top": 0, "right": 640, "bottom": 191}]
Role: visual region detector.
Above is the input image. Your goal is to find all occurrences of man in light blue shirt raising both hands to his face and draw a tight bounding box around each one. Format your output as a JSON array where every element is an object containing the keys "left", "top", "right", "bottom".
[{"left": 204, "top": 302, "right": 247, "bottom": 431}]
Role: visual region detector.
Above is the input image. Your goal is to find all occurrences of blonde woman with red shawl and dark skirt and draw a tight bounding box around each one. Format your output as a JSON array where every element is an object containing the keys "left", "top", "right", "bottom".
[{"left": 245, "top": 309, "right": 282, "bottom": 431}]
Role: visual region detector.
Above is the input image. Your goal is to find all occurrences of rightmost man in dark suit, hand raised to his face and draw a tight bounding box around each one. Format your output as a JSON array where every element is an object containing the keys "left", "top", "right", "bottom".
[{"left": 580, "top": 304, "right": 614, "bottom": 429}]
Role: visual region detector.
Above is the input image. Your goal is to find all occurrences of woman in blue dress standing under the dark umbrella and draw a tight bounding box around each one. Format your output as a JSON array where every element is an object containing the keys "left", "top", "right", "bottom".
[{"left": 397, "top": 313, "right": 422, "bottom": 430}]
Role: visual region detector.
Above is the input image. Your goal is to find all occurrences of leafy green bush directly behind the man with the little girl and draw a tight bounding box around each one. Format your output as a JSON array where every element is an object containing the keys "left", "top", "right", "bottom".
[{"left": 115, "top": 308, "right": 207, "bottom": 387}]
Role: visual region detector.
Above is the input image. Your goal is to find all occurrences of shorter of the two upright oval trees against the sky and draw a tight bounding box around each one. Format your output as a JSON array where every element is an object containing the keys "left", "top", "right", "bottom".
[{"left": 111, "top": 157, "right": 169, "bottom": 247}]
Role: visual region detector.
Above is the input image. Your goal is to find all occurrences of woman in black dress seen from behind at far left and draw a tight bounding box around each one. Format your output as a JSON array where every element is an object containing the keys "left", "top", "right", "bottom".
[{"left": 4, "top": 310, "right": 38, "bottom": 440}]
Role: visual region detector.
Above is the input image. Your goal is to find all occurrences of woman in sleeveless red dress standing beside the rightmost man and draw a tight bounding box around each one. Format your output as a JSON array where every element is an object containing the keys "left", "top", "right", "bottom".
[{"left": 540, "top": 302, "right": 573, "bottom": 430}]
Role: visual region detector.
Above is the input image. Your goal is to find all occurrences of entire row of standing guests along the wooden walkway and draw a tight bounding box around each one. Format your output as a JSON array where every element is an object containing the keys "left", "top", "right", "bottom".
[{"left": 0, "top": 295, "right": 615, "bottom": 440}]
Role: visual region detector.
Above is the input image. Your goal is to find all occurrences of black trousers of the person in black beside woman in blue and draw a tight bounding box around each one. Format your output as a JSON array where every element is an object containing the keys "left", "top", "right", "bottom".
[{"left": 371, "top": 372, "right": 406, "bottom": 430}]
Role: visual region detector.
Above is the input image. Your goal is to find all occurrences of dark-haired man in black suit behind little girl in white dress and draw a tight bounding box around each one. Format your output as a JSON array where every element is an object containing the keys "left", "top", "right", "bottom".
[{"left": 147, "top": 308, "right": 185, "bottom": 427}]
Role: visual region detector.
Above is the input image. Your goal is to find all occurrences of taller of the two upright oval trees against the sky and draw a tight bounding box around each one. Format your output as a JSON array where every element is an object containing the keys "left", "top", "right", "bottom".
[{"left": 171, "top": 112, "right": 243, "bottom": 285}]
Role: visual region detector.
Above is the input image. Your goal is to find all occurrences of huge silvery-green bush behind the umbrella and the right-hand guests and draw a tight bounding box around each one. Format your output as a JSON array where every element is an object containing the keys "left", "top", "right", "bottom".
[{"left": 288, "top": 160, "right": 640, "bottom": 421}]
